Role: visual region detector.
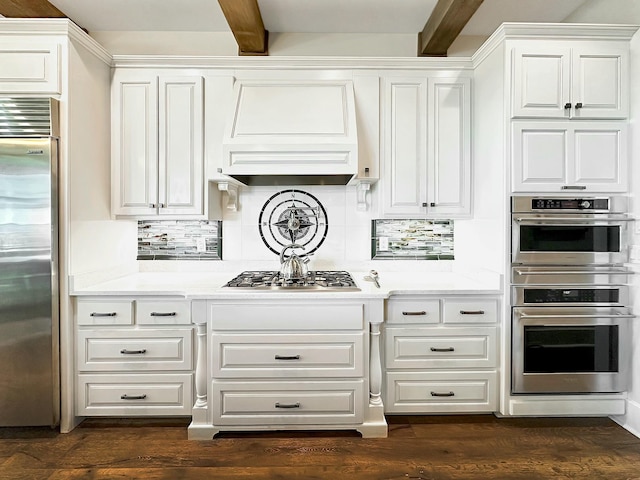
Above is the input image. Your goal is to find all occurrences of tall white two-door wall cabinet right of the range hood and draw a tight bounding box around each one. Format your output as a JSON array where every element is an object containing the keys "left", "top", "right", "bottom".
[{"left": 381, "top": 76, "right": 471, "bottom": 218}]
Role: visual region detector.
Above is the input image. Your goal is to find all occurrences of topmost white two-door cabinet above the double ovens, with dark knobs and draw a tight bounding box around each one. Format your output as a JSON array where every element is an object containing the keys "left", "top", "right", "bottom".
[{"left": 512, "top": 41, "right": 629, "bottom": 119}]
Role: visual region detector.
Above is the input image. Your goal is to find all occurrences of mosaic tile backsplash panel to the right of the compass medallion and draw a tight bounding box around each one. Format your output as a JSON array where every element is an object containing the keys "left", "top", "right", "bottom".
[{"left": 371, "top": 219, "right": 454, "bottom": 260}]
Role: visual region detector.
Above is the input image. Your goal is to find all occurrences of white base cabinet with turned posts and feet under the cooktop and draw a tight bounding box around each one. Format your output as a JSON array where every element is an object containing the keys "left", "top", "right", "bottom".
[{"left": 189, "top": 298, "right": 387, "bottom": 439}]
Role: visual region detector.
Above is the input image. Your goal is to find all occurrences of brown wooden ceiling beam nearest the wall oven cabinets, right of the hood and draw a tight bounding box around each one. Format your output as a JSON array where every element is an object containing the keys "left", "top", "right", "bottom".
[{"left": 418, "top": 0, "right": 484, "bottom": 57}]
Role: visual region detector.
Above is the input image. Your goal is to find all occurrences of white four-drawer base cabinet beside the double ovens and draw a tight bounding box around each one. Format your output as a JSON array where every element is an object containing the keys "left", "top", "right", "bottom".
[{"left": 383, "top": 296, "right": 499, "bottom": 413}]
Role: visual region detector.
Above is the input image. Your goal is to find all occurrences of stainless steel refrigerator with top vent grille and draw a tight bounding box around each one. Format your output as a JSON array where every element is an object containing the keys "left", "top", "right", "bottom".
[{"left": 0, "top": 98, "right": 60, "bottom": 427}]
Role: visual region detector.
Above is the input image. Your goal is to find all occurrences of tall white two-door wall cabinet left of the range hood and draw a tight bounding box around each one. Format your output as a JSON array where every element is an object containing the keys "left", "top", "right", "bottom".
[{"left": 112, "top": 70, "right": 204, "bottom": 217}]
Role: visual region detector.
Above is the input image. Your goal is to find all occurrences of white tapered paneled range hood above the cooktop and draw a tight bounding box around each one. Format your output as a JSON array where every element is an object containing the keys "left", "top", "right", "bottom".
[{"left": 222, "top": 80, "right": 358, "bottom": 185}]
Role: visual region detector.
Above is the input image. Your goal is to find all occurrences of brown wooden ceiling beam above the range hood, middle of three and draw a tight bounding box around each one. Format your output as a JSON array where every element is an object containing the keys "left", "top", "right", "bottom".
[{"left": 218, "top": 0, "right": 269, "bottom": 55}]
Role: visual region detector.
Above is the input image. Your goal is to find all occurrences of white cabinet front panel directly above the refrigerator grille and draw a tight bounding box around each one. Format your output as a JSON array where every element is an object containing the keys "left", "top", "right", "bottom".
[{"left": 0, "top": 41, "right": 60, "bottom": 94}]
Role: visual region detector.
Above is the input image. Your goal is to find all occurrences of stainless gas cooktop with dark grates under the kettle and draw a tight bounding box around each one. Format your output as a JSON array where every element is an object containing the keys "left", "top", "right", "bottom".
[{"left": 225, "top": 270, "right": 360, "bottom": 292}]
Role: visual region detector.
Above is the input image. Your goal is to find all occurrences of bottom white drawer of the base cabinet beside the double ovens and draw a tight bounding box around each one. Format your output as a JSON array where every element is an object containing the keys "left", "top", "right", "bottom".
[{"left": 384, "top": 371, "right": 498, "bottom": 413}]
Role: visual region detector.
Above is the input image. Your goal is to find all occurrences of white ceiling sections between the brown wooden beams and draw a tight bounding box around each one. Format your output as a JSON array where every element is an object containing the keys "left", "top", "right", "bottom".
[{"left": 49, "top": 0, "right": 590, "bottom": 36}]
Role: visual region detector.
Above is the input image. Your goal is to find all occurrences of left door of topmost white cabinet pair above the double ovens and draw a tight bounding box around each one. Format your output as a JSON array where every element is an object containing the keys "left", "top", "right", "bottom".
[{"left": 512, "top": 45, "right": 571, "bottom": 118}]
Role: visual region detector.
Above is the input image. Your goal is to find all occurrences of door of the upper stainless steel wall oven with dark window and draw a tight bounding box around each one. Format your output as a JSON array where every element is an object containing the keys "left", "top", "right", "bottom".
[{"left": 512, "top": 215, "right": 627, "bottom": 265}]
